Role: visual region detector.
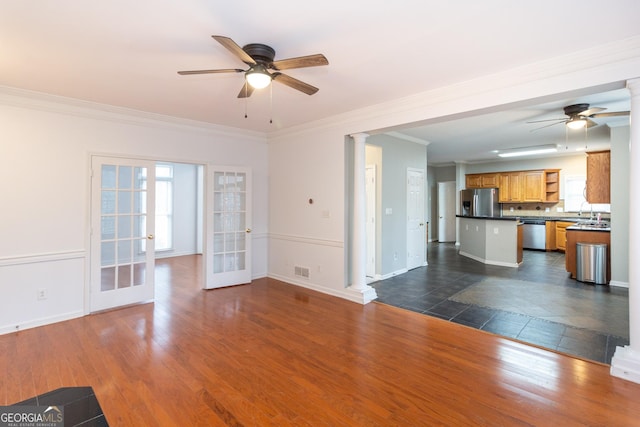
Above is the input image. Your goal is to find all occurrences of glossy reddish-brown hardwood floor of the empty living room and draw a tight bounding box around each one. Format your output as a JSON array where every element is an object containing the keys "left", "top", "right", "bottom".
[{"left": 0, "top": 256, "right": 640, "bottom": 426}]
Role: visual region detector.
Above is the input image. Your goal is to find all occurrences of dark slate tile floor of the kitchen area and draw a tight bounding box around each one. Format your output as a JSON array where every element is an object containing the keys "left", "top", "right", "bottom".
[{"left": 371, "top": 243, "right": 629, "bottom": 364}]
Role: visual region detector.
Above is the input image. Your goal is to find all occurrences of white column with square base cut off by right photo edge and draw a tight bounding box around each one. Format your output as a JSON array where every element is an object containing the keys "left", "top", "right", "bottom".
[{"left": 611, "top": 78, "right": 640, "bottom": 383}]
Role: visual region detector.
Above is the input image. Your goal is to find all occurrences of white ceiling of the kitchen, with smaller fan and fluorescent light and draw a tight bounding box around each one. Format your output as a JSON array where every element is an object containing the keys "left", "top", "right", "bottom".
[{"left": 393, "top": 89, "right": 630, "bottom": 165}]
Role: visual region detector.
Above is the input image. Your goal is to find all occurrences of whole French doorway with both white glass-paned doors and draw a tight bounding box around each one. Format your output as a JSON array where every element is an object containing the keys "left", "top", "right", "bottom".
[{"left": 88, "top": 156, "right": 251, "bottom": 312}]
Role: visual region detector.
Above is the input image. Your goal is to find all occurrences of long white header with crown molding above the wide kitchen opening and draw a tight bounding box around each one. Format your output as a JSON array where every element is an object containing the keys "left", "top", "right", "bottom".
[{"left": 268, "top": 36, "right": 640, "bottom": 141}]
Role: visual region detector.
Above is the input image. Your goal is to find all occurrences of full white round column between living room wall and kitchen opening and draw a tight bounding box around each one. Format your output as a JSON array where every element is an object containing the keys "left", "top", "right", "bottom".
[{"left": 348, "top": 133, "right": 378, "bottom": 304}]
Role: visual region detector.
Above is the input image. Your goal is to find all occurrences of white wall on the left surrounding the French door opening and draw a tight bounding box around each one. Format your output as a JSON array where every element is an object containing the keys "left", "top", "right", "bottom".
[{"left": 0, "top": 90, "right": 268, "bottom": 333}]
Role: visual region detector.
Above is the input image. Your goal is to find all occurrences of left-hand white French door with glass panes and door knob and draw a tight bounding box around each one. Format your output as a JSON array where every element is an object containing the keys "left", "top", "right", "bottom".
[{"left": 90, "top": 156, "right": 155, "bottom": 312}]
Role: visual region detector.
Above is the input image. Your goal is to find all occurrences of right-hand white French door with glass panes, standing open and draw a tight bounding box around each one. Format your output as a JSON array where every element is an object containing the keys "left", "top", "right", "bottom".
[{"left": 205, "top": 166, "right": 251, "bottom": 289}]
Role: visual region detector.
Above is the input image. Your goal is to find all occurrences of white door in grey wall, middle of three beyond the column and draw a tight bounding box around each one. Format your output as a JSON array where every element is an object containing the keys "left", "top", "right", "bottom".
[{"left": 407, "top": 168, "right": 427, "bottom": 270}]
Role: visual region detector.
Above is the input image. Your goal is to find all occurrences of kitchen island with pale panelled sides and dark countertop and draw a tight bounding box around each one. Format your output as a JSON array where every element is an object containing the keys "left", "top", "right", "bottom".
[{"left": 457, "top": 215, "right": 522, "bottom": 267}]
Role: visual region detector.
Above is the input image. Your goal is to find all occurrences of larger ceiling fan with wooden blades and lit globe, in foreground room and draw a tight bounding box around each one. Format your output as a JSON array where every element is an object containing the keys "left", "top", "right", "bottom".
[{"left": 178, "top": 36, "right": 329, "bottom": 98}]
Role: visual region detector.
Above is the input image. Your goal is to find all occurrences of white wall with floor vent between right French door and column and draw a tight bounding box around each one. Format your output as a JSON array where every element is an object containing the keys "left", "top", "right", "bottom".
[{"left": 269, "top": 129, "right": 346, "bottom": 296}]
